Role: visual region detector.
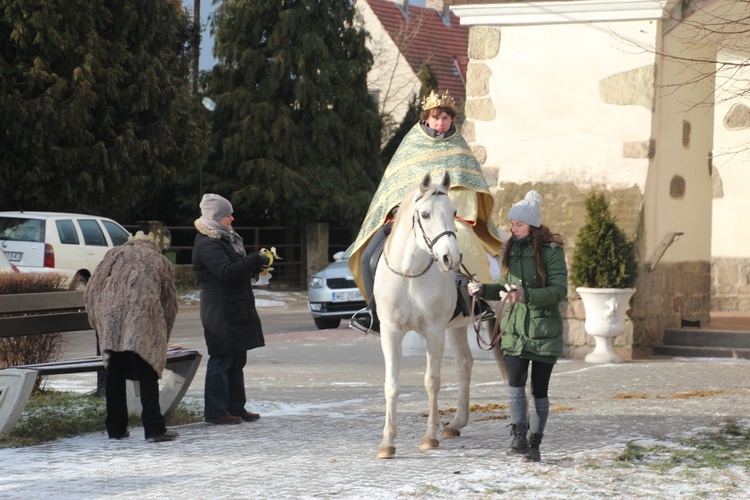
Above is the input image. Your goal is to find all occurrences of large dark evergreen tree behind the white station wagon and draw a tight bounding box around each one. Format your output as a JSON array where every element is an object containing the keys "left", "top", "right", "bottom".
[{"left": 0, "top": 0, "right": 209, "bottom": 221}]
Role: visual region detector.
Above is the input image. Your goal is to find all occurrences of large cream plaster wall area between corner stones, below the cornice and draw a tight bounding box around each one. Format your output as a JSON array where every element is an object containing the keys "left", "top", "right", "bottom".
[{"left": 476, "top": 21, "right": 657, "bottom": 192}]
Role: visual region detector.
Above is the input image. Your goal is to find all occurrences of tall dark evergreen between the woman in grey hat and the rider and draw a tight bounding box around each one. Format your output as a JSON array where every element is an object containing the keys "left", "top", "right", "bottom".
[{"left": 208, "top": 0, "right": 382, "bottom": 228}]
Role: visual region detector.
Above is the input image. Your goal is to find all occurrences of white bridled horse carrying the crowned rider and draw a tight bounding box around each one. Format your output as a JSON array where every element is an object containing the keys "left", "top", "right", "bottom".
[{"left": 373, "top": 171, "right": 506, "bottom": 458}]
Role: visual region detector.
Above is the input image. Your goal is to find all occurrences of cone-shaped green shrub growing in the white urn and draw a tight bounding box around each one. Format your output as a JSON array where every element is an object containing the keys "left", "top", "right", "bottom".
[{"left": 570, "top": 192, "right": 638, "bottom": 288}]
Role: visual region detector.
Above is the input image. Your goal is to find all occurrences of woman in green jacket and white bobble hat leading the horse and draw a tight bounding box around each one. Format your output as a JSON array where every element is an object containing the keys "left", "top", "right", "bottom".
[{"left": 469, "top": 190, "right": 568, "bottom": 462}]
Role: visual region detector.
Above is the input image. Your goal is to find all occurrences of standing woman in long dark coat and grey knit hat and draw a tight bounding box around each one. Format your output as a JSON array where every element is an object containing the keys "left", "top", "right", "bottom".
[{"left": 192, "top": 193, "right": 269, "bottom": 424}]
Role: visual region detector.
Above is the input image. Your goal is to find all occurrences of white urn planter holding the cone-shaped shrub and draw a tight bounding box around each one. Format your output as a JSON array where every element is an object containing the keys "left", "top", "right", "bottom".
[{"left": 576, "top": 287, "right": 635, "bottom": 363}]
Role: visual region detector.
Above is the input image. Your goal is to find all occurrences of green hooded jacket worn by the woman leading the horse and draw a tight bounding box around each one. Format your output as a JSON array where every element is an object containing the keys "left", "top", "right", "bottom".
[{"left": 481, "top": 241, "right": 568, "bottom": 358}]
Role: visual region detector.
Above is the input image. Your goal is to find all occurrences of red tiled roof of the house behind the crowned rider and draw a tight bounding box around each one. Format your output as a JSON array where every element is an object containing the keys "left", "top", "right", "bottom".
[{"left": 366, "top": 0, "right": 469, "bottom": 106}]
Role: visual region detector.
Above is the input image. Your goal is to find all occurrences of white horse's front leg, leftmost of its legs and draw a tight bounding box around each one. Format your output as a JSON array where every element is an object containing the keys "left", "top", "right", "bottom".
[{"left": 377, "top": 330, "right": 404, "bottom": 458}]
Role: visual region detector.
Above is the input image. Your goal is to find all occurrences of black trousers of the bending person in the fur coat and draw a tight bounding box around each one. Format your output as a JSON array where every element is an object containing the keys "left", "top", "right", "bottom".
[{"left": 105, "top": 351, "right": 167, "bottom": 439}]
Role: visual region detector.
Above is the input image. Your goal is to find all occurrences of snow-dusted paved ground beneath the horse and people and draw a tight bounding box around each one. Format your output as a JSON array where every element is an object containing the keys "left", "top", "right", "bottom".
[{"left": 0, "top": 304, "right": 750, "bottom": 499}]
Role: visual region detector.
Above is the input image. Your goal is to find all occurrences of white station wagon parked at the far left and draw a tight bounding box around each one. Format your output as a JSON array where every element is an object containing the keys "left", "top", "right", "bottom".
[{"left": 0, "top": 212, "right": 130, "bottom": 288}]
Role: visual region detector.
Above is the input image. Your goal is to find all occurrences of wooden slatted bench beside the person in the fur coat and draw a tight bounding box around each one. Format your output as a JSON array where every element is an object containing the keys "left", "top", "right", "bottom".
[{"left": 0, "top": 291, "right": 202, "bottom": 434}]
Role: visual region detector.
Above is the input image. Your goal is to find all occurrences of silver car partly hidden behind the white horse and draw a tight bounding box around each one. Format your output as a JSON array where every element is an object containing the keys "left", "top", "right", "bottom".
[{"left": 307, "top": 245, "right": 366, "bottom": 330}]
